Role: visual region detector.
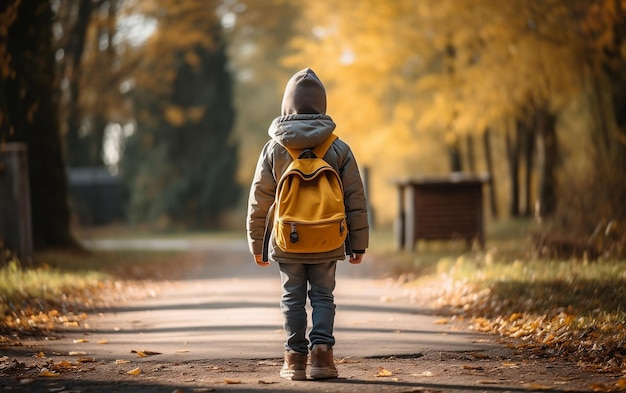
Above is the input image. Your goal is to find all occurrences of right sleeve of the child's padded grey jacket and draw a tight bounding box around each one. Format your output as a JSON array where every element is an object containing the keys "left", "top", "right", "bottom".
[{"left": 339, "top": 141, "right": 369, "bottom": 252}]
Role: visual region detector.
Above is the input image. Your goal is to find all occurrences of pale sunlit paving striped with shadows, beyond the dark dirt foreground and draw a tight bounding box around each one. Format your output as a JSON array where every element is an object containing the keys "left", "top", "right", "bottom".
[{"left": 50, "top": 236, "right": 493, "bottom": 360}]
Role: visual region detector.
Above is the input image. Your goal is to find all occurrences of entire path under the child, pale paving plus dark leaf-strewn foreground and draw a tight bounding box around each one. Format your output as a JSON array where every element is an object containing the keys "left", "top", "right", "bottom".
[{"left": 0, "top": 242, "right": 623, "bottom": 393}]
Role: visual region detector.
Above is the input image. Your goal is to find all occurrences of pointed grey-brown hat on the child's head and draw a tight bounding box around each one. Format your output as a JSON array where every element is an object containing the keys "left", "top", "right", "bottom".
[{"left": 281, "top": 68, "right": 326, "bottom": 116}]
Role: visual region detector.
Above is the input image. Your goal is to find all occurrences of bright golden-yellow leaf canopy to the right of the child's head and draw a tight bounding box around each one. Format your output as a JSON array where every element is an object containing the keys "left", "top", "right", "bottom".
[{"left": 272, "top": 0, "right": 619, "bottom": 224}]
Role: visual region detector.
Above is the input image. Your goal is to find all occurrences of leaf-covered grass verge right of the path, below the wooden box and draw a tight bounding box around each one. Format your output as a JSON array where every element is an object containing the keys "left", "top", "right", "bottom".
[{"left": 394, "top": 221, "right": 626, "bottom": 372}]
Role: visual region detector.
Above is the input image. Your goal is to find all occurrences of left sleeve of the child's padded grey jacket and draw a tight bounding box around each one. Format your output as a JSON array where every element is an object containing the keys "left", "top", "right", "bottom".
[{"left": 246, "top": 142, "right": 276, "bottom": 255}]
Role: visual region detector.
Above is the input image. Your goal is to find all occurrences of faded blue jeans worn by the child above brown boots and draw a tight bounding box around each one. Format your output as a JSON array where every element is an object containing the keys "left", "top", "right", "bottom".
[{"left": 279, "top": 261, "right": 337, "bottom": 354}]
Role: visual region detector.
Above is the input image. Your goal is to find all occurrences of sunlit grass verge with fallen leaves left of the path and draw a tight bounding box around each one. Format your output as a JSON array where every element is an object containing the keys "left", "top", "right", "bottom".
[{"left": 0, "top": 245, "right": 192, "bottom": 337}]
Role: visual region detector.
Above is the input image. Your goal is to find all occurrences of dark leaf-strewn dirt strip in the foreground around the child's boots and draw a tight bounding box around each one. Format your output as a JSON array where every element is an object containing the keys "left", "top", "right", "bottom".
[{"left": 0, "top": 346, "right": 612, "bottom": 393}]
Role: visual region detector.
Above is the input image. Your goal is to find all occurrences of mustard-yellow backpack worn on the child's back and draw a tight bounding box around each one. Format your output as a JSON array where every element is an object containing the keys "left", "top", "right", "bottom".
[{"left": 263, "top": 134, "right": 348, "bottom": 260}]
